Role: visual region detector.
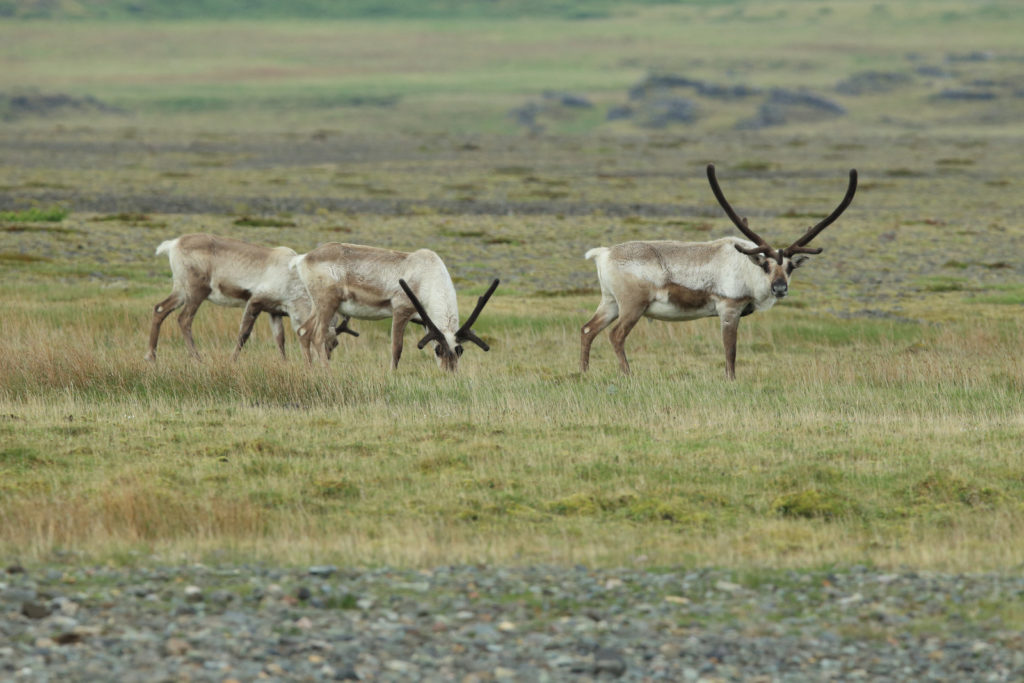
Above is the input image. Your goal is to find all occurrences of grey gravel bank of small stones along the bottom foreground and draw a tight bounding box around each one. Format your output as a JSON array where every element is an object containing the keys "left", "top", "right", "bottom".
[{"left": 0, "top": 565, "right": 1024, "bottom": 681}]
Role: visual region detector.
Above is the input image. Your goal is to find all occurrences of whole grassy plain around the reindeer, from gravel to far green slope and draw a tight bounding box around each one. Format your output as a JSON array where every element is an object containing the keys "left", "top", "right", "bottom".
[{"left": 0, "top": 2, "right": 1024, "bottom": 571}]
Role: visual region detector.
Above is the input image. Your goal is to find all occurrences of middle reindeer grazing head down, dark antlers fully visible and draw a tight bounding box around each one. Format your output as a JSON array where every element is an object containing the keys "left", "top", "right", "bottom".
[{"left": 292, "top": 242, "right": 499, "bottom": 372}]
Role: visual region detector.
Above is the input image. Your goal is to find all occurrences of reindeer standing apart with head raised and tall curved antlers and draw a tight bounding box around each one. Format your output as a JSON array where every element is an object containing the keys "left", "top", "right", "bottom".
[{"left": 580, "top": 164, "right": 857, "bottom": 379}]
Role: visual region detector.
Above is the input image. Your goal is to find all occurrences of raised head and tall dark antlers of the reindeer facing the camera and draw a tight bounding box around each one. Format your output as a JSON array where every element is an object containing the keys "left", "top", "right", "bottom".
[{"left": 708, "top": 164, "right": 857, "bottom": 299}]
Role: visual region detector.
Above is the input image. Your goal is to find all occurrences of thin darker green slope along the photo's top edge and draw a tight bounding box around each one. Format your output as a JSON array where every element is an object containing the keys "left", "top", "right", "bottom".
[{"left": 0, "top": 0, "right": 745, "bottom": 19}]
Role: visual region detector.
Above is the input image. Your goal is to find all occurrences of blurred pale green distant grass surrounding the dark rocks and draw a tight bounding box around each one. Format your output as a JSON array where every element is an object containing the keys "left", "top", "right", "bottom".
[{"left": 0, "top": 0, "right": 1022, "bottom": 136}]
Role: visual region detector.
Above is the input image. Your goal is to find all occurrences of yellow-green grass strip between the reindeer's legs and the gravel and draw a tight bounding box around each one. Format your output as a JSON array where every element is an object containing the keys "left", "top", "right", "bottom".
[{"left": 0, "top": 280, "right": 1024, "bottom": 569}]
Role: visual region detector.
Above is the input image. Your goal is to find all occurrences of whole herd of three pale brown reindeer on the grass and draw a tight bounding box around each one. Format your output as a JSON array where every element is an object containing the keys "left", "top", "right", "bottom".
[{"left": 145, "top": 164, "right": 857, "bottom": 379}]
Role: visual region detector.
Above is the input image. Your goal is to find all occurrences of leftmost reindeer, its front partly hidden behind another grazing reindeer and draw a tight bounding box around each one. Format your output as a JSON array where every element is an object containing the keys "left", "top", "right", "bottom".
[{"left": 145, "top": 233, "right": 358, "bottom": 361}]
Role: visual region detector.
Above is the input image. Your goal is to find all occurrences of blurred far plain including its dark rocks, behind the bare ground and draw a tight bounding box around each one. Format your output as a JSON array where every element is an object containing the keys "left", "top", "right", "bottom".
[{"left": 0, "top": 0, "right": 1024, "bottom": 135}]
